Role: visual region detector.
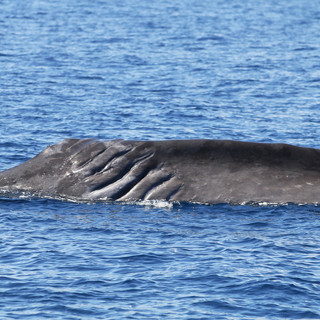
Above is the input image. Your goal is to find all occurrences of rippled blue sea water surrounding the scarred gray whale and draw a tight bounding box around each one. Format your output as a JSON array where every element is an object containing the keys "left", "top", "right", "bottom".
[{"left": 0, "top": 0, "right": 320, "bottom": 319}]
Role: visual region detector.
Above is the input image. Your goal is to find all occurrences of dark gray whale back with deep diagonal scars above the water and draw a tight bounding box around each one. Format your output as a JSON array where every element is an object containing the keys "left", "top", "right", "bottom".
[{"left": 0, "top": 139, "right": 320, "bottom": 204}]
